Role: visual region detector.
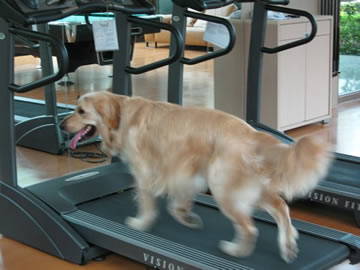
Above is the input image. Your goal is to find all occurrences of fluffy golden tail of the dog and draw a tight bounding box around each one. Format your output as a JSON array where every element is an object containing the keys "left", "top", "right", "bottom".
[{"left": 266, "top": 136, "right": 332, "bottom": 200}]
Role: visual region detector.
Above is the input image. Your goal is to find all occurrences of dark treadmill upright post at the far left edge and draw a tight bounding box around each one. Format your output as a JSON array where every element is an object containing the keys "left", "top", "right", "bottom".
[{"left": 0, "top": 18, "right": 17, "bottom": 187}]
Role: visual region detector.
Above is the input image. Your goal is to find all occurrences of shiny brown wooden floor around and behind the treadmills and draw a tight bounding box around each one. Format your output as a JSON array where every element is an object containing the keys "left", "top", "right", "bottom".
[{"left": 0, "top": 43, "right": 360, "bottom": 270}]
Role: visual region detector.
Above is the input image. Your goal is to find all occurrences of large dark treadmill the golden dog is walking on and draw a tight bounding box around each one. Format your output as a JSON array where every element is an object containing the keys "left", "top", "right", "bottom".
[{"left": 0, "top": 0, "right": 360, "bottom": 270}]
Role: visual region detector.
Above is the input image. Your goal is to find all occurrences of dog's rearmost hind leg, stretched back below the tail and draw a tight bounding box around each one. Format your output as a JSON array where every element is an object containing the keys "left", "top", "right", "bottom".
[{"left": 259, "top": 191, "right": 298, "bottom": 263}]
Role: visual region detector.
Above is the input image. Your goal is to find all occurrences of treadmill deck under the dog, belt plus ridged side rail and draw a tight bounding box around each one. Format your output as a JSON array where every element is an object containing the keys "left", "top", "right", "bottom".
[{"left": 63, "top": 190, "right": 350, "bottom": 270}]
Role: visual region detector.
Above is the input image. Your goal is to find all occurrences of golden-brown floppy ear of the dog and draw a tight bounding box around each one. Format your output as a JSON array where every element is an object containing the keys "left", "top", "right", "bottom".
[{"left": 95, "top": 97, "right": 120, "bottom": 129}]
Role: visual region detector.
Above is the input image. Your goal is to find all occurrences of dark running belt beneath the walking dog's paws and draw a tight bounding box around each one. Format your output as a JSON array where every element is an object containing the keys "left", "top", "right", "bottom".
[{"left": 64, "top": 190, "right": 350, "bottom": 270}]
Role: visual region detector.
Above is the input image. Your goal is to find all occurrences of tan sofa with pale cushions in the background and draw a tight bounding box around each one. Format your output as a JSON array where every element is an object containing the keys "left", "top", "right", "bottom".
[{"left": 144, "top": 4, "right": 238, "bottom": 47}]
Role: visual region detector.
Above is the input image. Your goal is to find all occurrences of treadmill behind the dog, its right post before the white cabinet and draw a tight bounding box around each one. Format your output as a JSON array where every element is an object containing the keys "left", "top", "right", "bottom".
[{"left": 168, "top": 0, "right": 360, "bottom": 227}]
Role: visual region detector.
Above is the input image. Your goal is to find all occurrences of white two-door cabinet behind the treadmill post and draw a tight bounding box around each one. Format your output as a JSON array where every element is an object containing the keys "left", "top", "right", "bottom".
[{"left": 214, "top": 16, "right": 332, "bottom": 131}]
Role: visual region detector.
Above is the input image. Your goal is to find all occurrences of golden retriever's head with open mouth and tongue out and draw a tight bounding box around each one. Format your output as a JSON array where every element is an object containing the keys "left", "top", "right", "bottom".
[{"left": 60, "top": 92, "right": 124, "bottom": 149}]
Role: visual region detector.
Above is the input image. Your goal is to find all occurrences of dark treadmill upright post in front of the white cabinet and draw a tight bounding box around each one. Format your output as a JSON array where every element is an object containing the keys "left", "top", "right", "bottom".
[{"left": 246, "top": 1, "right": 267, "bottom": 122}]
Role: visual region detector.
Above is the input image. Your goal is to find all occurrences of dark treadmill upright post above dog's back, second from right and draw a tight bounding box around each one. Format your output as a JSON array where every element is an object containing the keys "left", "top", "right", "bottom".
[{"left": 168, "top": 3, "right": 186, "bottom": 105}]
